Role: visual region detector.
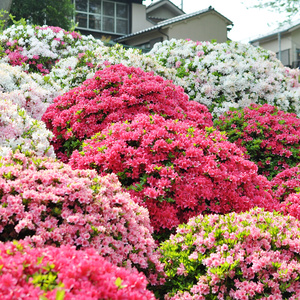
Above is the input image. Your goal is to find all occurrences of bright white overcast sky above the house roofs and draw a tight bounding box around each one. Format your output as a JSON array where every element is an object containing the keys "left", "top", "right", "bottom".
[{"left": 143, "top": 0, "right": 290, "bottom": 43}]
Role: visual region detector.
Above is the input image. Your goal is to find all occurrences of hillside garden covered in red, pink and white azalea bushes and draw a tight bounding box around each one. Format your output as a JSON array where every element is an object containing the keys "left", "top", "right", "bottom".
[{"left": 0, "top": 24, "right": 300, "bottom": 300}]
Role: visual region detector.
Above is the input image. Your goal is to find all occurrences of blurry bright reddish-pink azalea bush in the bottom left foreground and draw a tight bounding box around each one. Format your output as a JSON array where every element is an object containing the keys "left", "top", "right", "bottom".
[{"left": 0, "top": 241, "right": 155, "bottom": 300}]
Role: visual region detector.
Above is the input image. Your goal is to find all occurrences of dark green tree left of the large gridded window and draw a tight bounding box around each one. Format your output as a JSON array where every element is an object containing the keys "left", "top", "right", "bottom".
[{"left": 10, "top": 0, "right": 75, "bottom": 30}]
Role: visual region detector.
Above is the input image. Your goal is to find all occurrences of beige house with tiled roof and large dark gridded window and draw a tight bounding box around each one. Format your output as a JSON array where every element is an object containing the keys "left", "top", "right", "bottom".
[{"left": 73, "top": 0, "right": 233, "bottom": 48}]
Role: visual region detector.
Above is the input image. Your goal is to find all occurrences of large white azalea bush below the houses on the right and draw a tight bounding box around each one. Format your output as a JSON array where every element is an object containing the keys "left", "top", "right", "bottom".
[{"left": 149, "top": 39, "right": 300, "bottom": 116}]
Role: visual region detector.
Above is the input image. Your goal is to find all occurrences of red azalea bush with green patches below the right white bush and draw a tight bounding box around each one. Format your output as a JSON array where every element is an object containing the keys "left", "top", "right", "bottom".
[{"left": 214, "top": 104, "right": 300, "bottom": 179}]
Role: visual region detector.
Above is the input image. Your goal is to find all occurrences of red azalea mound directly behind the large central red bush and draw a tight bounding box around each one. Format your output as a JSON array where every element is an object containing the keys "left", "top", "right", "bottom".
[{"left": 42, "top": 64, "right": 212, "bottom": 160}]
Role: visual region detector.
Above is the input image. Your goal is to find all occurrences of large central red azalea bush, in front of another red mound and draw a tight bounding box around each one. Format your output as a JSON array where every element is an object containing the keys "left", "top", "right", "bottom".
[{"left": 69, "top": 114, "right": 276, "bottom": 236}]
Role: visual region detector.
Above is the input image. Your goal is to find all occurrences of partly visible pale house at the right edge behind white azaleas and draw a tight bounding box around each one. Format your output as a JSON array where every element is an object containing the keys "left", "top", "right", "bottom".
[{"left": 249, "top": 20, "right": 300, "bottom": 68}]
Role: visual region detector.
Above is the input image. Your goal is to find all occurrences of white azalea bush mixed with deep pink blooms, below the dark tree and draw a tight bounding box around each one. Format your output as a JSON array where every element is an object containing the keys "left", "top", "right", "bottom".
[{"left": 0, "top": 25, "right": 103, "bottom": 74}]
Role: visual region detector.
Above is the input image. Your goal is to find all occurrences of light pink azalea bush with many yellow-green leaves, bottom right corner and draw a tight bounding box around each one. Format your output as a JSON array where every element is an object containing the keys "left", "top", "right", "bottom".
[{"left": 160, "top": 208, "right": 300, "bottom": 300}]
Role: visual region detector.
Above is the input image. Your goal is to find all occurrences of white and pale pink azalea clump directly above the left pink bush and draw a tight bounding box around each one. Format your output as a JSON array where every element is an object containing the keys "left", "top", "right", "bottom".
[{"left": 0, "top": 99, "right": 55, "bottom": 157}]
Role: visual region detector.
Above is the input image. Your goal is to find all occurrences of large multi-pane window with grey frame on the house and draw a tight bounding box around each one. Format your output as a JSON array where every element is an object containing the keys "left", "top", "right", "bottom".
[{"left": 74, "top": 0, "right": 129, "bottom": 34}]
